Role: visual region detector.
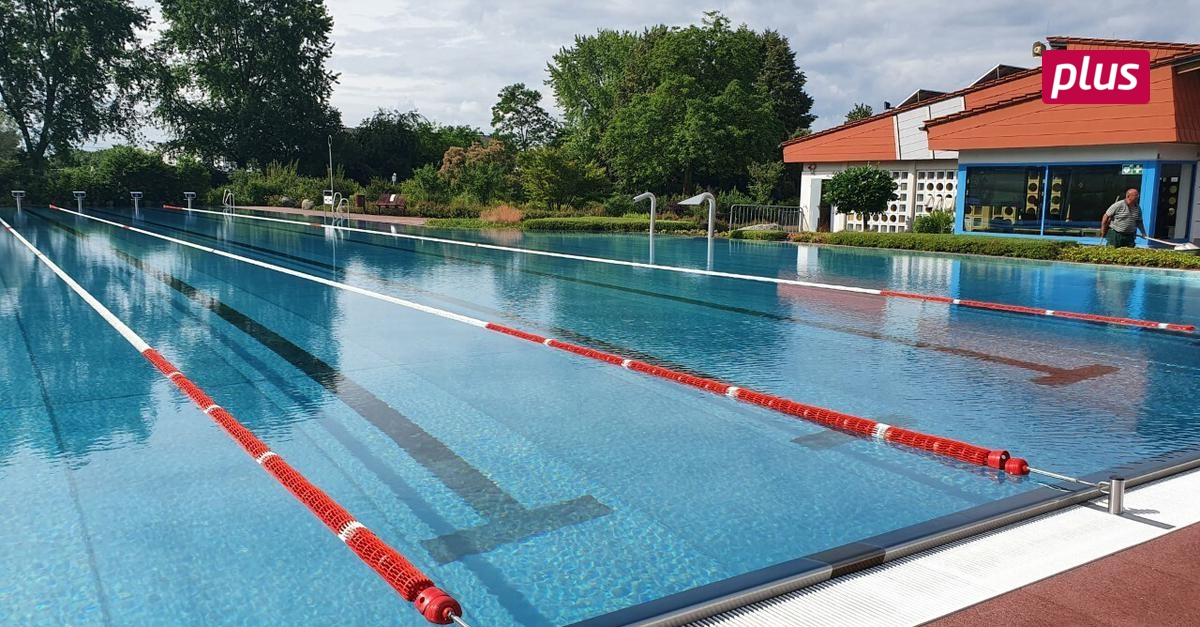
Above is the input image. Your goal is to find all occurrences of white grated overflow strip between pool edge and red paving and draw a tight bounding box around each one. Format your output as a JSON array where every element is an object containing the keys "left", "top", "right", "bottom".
[{"left": 692, "top": 471, "right": 1200, "bottom": 627}]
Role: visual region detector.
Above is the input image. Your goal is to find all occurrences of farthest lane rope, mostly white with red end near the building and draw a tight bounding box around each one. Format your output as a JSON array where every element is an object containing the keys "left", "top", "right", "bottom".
[{"left": 157, "top": 204, "right": 1195, "bottom": 333}]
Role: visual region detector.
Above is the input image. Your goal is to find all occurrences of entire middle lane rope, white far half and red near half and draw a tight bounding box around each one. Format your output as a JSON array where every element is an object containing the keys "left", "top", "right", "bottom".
[{"left": 50, "top": 204, "right": 1030, "bottom": 474}]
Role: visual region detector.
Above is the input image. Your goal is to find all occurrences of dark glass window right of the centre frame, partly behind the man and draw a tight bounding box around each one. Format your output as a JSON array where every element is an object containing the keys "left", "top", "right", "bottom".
[{"left": 1045, "top": 163, "right": 1146, "bottom": 238}]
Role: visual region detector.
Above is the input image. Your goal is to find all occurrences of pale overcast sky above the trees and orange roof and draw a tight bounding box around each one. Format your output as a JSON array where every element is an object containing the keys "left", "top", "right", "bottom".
[{"left": 131, "top": 0, "right": 1200, "bottom": 141}]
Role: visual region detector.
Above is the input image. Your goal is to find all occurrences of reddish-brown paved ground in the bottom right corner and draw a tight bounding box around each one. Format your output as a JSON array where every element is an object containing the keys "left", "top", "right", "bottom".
[{"left": 929, "top": 525, "right": 1200, "bottom": 627}]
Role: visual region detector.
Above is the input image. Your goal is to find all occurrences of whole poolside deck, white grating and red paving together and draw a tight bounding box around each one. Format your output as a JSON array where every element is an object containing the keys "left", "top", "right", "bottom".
[{"left": 694, "top": 471, "right": 1200, "bottom": 627}]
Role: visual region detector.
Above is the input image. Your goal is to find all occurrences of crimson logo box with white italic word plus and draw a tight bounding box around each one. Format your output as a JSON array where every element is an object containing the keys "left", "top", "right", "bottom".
[{"left": 1042, "top": 50, "right": 1150, "bottom": 105}]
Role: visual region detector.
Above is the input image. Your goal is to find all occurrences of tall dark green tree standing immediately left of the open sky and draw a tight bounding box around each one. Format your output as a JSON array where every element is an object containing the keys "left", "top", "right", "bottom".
[{"left": 156, "top": 0, "right": 341, "bottom": 168}]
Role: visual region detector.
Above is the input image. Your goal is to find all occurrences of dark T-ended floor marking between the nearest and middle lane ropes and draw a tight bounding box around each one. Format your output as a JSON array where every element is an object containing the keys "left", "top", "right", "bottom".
[{"left": 40, "top": 216, "right": 612, "bottom": 563}]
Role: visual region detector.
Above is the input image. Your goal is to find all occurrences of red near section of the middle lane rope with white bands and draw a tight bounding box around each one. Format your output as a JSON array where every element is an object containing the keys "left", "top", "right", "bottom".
[{"left": 485, "top": 322, "right": 1030, "bottom": 474}]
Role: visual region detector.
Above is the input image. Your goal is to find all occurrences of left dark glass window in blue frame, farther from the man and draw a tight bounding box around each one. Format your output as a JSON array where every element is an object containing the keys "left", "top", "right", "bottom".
[{"left": 962, "top": 167, "right": 1045, "bottom": 235}]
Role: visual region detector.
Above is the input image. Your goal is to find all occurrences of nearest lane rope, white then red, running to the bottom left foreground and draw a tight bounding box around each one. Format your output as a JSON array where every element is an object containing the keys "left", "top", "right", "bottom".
[{"left": 0, "top": 212, "right": 466, "bottom": 625}]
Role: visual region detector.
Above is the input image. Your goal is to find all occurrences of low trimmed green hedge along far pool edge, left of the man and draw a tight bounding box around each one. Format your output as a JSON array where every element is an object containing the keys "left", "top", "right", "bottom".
[{"left": 792, "top": 231, "right": 1079, "bottom": 259}]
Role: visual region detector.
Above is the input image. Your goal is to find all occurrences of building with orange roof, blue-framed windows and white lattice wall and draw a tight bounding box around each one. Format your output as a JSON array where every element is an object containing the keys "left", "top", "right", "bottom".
[{"left": 784, "top": 37, "right": 1200, "bottom": 243}]
